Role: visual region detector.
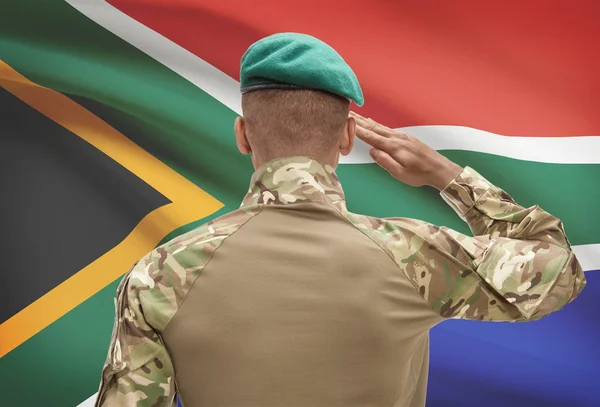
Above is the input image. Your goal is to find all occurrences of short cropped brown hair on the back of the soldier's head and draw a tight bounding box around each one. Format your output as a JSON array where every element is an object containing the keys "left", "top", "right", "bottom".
[{"left": 242, "top": 89, "right": 350, "bottom": 162}]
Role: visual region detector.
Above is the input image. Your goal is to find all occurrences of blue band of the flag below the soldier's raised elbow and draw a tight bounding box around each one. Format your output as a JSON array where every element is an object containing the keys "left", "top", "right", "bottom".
[{"left": 427, "top": 272, "right": 600, "bottom": 407}]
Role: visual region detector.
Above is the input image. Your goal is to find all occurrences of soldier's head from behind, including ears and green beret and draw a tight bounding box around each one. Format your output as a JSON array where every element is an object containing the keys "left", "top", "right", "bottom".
[{"left": 236, "top": 33, "right": 364, "bottom": 167}]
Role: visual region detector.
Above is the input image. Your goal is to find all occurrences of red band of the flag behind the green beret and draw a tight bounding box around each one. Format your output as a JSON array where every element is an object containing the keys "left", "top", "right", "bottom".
[{"left": 110, "top": 0, "right": 600, "bottom": 136}]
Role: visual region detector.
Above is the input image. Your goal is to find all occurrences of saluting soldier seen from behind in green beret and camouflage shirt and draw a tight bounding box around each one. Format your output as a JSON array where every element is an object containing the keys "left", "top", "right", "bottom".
[{"left": 96, "top": 33, "right": 585, "bottom": 407}]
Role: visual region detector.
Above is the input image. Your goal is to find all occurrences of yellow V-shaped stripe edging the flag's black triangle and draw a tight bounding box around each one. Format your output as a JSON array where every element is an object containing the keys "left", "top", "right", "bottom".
[{"left": 0, "top": 60, "right": 223, "bottom": 357}]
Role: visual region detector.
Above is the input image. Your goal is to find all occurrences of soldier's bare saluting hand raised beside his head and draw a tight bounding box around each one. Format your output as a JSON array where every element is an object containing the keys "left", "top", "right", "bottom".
[{"left": 350, "top": 112, "right": 462, "bottom": 190}]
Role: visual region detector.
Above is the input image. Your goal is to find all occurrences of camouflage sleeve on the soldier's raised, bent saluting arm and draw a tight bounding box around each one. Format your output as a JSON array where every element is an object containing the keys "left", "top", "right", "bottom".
[{"left": 378, "top": 167, "right": 585, "bottom": 321}]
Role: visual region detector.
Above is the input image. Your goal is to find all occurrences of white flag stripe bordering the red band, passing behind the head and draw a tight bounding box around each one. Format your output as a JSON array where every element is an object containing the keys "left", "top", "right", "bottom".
[{"left": 67, "top": 0, "right": 600, "bottom": 164}]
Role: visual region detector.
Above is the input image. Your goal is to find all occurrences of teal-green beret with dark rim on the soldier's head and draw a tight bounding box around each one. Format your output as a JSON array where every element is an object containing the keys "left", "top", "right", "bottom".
[{"left": 240, "top": 33, "right": 364, "bottom": 106}]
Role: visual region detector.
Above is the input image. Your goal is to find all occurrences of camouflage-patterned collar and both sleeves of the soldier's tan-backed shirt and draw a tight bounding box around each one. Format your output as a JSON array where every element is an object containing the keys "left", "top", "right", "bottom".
[{"left": 96, "top": 157, "right": 585, "bottom": 407}]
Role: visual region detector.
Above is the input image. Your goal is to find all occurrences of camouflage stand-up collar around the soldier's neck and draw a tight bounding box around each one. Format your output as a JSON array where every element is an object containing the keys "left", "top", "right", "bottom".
[{"left": 241, "top": 156, "right": 344, "bottom": 207}]
